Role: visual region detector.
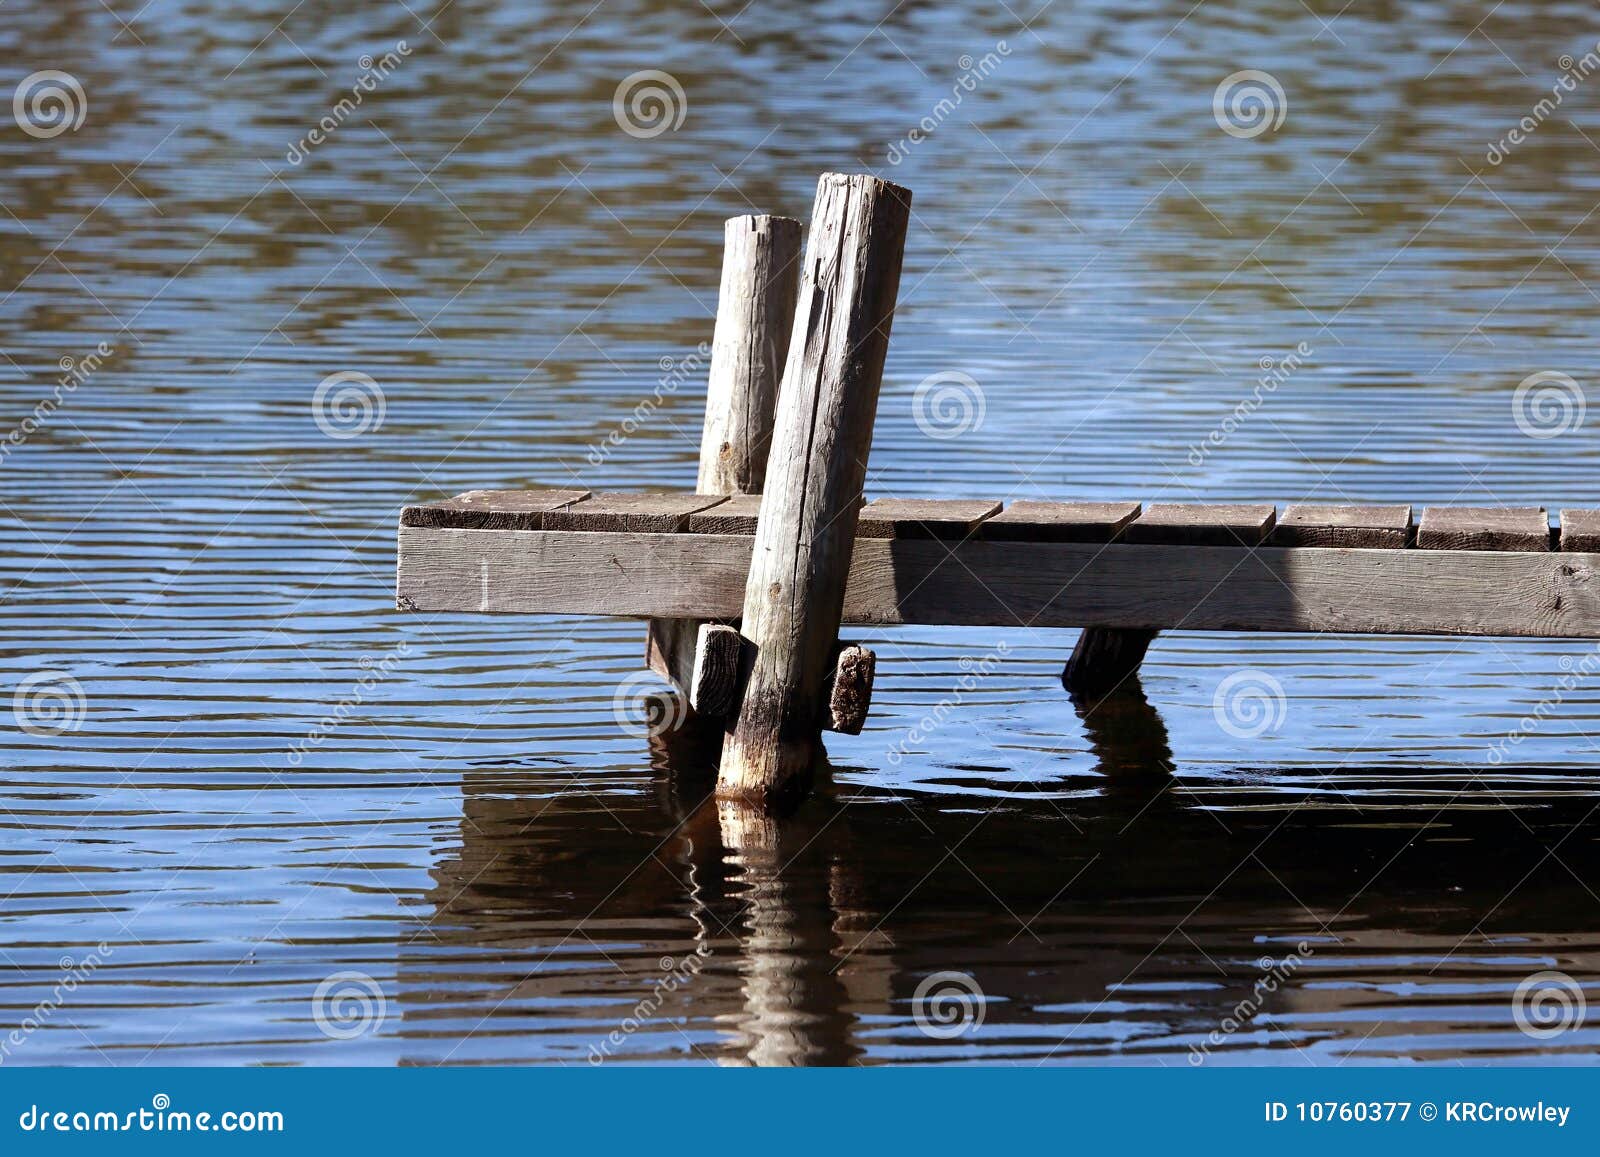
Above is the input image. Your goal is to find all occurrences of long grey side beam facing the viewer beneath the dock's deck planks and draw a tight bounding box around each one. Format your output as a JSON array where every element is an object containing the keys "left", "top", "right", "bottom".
[{"left": 398, "top": 526, "right": 1600, "bottom": 639}]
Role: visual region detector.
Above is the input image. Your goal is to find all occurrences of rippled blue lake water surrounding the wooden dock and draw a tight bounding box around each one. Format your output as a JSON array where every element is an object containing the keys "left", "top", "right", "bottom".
[{"left": 0, "top": 0, "right": 1600, "bottom": 1066}]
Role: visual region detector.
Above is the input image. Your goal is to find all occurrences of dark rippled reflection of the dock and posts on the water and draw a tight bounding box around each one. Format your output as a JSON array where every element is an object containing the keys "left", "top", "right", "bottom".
[{"left": 402, "top": 713, "right": 1600, "bottom": 1064}]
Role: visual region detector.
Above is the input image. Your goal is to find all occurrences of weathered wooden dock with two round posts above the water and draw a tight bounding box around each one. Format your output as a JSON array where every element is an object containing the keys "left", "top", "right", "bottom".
[{"left": 397, "top": 173, "right": 1600, "bottom": 810}]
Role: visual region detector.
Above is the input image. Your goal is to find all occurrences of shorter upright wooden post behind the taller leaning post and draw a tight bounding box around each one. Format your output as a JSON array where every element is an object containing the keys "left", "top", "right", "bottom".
[{"left": 645, "top": 216, "right": 800, "bottom": 695}]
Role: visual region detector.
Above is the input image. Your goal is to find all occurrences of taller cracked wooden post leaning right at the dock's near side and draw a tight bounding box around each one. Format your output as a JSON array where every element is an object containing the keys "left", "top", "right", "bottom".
[{"left": 717, "top": 173, "right": 910, "bottom": 807}]
